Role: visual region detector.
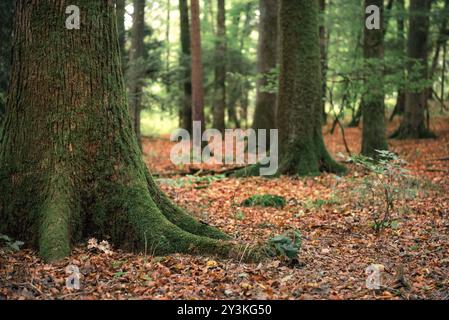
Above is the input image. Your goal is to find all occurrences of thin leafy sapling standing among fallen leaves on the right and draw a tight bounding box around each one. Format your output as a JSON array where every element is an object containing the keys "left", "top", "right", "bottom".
[{"left": 351, "top": 150, "right": 412, "bottom": 232}]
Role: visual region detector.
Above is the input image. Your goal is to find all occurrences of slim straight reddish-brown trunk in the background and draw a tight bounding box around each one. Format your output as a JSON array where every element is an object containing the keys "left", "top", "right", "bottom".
[{"left": 190, "top": 0, "right": 204, "bottom": 128}]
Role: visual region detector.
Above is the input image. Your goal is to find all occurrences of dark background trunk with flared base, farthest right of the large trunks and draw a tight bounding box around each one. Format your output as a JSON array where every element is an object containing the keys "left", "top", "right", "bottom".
[{"left": 393, "top": 0, "right": 434, "bottom": 139}]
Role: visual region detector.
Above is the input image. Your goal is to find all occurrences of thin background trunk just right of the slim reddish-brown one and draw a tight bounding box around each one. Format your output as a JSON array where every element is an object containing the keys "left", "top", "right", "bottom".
[{"left": 213, "top": 0, "right": 226, "bottom": 133}]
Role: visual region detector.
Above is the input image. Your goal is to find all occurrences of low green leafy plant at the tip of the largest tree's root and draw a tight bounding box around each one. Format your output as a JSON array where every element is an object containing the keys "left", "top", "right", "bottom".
[{"left": 268, "top": 230, "right": 302, "bottom": 260}]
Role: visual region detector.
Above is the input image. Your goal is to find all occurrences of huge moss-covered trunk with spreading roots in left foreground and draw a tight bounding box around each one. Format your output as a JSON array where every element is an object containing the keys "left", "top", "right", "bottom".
[{"left": 0, "top": 0, "right": 245, "bottom": 261}]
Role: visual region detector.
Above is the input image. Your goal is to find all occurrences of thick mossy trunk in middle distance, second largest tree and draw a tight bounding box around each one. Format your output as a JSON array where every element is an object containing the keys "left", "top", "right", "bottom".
[{"left": 277, "top": 0, "right": 344, "bottom": 175}]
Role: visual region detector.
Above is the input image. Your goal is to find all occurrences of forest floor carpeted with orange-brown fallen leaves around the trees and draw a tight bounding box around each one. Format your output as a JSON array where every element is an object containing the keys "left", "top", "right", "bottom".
[{"left": 0, "top": 117, "right": 449, "bottom": 299}]
